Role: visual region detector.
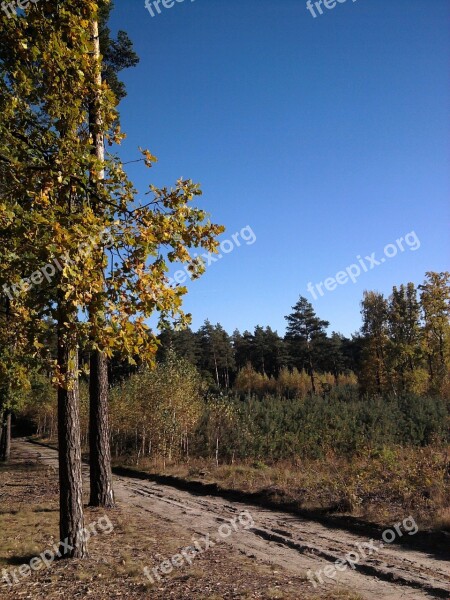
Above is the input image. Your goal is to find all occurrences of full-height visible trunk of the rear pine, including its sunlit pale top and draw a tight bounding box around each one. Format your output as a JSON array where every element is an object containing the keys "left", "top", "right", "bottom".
[{"left": 89, "top": 21, "right": 114, "bottom": 508}]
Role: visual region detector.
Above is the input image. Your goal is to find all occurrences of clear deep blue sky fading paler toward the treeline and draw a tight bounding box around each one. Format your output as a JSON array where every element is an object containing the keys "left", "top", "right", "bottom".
[{"left": 112, "top": 0, "right": 450, "bottom": 335}]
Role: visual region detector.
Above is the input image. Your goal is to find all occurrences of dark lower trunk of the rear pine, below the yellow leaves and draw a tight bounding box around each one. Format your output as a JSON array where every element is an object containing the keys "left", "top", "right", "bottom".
[{"left": 89, "top": 351, "right": 114, "bottom": 508}]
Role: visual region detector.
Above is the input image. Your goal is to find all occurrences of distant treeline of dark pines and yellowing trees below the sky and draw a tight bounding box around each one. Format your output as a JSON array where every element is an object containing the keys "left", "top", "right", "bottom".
[{"left": 147, "top": 272, "right": 450, "bottom": 397}]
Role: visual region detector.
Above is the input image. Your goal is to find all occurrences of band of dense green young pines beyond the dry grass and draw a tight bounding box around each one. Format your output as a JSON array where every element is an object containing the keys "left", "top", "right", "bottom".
[{"left": 192, "top": 386, "right": 449, "bottom": 462}]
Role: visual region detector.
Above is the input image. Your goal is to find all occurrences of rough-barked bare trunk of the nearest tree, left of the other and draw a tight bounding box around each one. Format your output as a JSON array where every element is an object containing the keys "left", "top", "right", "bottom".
[{"left": 58, "top": 324, "right": 87, "bottom": 558}]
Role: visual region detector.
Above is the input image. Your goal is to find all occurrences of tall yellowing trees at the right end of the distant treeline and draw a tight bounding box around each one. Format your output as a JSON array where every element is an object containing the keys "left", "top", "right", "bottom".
[{"left": 360, "top": 272, "right": 450, "bottom": 398}]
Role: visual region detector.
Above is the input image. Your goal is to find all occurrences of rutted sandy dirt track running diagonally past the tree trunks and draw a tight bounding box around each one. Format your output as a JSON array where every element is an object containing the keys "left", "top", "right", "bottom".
[{"left": 14, "top": 440, "right": 450, "bottom": 600}]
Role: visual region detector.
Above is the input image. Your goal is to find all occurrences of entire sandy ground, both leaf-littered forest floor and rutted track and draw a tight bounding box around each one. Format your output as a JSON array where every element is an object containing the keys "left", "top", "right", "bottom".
[{"left": 0, "top": 440, "right": 450, "bottom": 600}]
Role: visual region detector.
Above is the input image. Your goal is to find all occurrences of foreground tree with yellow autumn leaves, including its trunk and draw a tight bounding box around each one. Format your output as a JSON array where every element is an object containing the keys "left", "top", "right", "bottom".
[{"left": 0, "top": 0, "right": 223, "bottom": 557}]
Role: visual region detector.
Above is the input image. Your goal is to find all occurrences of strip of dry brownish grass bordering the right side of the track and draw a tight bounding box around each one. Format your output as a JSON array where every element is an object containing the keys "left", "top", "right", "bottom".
[{"left": 130, "top": 447, "right": 450, "bottom": 531}]
